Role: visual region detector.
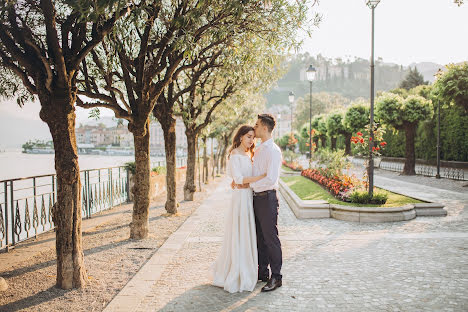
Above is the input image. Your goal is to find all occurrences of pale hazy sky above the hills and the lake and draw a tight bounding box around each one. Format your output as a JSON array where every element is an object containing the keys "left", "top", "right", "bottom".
[{"left": 0, "top": 0, "right": 468, "bottom": 149}]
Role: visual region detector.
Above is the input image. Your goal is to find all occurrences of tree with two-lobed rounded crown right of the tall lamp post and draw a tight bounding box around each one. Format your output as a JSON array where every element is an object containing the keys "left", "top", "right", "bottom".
[{"left": 376, "top": 93, "right": 433, "bottom": 175}]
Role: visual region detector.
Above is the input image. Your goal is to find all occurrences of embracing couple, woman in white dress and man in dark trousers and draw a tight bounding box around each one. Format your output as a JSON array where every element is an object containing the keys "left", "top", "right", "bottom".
[{"left": 212, "top": 114, "right": 282, "bottom": 293}]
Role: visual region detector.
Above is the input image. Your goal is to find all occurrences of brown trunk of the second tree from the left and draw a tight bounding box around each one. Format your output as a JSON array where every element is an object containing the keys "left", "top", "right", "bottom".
[{"left": 129, "top": 118, "right": 150, "bottom": 239}]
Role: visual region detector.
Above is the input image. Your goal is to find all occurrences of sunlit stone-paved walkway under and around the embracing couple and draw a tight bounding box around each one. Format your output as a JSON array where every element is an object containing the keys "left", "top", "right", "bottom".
[{"left": 105, "top": 177, "right": 468, "bottom": 312}]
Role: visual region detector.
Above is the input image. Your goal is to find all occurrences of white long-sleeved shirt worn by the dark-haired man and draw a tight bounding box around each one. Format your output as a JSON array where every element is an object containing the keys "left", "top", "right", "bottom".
[{"left": 250, "top": 139, "right": 282, "bottom": 192}]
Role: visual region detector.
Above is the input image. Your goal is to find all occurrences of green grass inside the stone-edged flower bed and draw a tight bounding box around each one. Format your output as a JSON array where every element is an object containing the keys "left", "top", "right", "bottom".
[{"left": 281, "top": 176, "right": 422, "bottom": 207}]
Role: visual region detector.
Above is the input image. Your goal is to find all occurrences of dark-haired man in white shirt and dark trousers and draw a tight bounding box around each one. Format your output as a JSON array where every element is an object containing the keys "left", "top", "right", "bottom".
[{"left": 233, "top": 114, "right": 283, "bottom": 291}]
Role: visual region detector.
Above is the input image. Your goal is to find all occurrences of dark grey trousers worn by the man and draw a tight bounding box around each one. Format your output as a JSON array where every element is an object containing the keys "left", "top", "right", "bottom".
[{"left": 253, "top": 191, "right": 283, "bottom": 279}]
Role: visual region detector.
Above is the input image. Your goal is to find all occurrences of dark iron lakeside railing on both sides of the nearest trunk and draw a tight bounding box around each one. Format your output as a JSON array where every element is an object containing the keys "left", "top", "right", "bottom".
[{"left": 0, "top": 167, "right": 129, "bottom": 250}]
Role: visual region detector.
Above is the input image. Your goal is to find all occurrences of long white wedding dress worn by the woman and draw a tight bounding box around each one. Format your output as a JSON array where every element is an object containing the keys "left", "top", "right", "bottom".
[{"left": 211, "top": 154, "right": 258, "bottom": 293}]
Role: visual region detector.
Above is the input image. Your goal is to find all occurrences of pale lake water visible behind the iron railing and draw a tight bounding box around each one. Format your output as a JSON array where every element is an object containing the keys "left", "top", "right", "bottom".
[{"left": 0, "top": 149, "right": 164, "bottom": 180}]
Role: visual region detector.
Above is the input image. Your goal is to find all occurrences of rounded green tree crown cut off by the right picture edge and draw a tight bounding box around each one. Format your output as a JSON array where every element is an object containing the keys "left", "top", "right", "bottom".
[{"left": 434, "top": 62, "right": 468, "bottom": 112}]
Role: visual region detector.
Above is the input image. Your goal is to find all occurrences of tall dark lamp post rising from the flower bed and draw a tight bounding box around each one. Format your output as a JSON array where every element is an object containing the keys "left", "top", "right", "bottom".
[{"left": 366, "top": 0, "right": 380, "bottom": 198}]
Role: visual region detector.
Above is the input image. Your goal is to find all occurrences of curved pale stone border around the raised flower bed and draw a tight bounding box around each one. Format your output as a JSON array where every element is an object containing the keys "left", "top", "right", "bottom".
[{"left": 279, "top": 179, "right": 447, "bottom": 223}]
